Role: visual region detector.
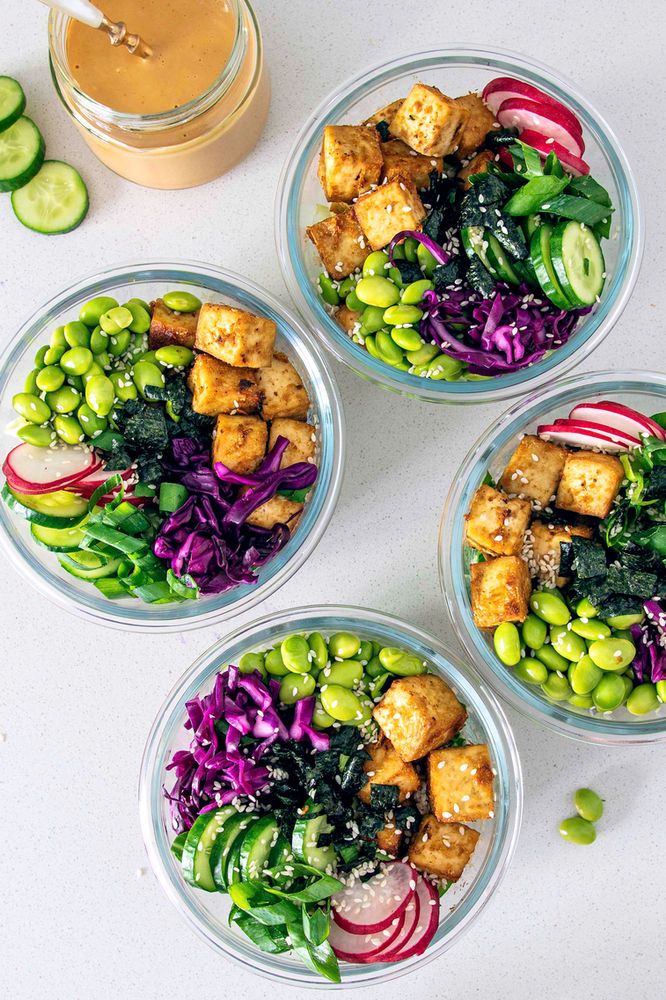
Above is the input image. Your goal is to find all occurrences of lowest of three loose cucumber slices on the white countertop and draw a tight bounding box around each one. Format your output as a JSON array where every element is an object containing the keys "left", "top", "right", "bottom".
[{"left": 11, "top": 162, "right": 89, "bottom": 235}]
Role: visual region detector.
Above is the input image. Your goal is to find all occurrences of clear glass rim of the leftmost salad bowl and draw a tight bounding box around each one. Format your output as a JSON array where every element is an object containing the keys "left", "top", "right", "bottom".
[{"left": 0, "top": 258, "right": 346, "bottom": 633}]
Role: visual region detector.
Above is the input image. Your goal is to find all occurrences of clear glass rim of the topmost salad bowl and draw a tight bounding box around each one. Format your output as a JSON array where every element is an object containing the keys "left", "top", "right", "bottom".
[{"left": 275, "top": 45, "right": 645, "bottom": 403}]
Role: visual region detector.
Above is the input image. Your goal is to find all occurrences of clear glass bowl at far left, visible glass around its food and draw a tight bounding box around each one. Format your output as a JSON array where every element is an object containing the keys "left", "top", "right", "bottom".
[{"left": 0, "top": 261, "right": 345, "bottom": 631}]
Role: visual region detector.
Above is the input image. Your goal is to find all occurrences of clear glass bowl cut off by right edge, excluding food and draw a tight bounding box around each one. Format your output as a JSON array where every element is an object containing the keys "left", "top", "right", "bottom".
[{"left": 438, "top": 372, "right": 666, "bottom": 745}]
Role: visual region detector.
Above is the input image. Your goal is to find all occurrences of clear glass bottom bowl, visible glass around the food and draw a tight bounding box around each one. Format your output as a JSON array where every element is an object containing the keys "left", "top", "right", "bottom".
[{"left": 139, "top": 606, "right": 522, "bottom": 989}]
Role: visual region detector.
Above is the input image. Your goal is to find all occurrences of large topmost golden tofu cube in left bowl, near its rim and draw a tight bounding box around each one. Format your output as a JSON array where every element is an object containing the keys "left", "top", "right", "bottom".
[{"left": 194, "top": 302, "right": 277, "bottom": 368}]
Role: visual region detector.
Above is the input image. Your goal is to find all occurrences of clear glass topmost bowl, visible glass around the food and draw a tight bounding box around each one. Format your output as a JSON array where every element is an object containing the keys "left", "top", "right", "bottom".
[{"left": 275, "top": 45, "right": 644, "bottom": 403}]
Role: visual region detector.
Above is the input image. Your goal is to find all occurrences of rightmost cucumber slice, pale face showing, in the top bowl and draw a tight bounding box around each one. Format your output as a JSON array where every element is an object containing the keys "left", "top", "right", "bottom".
[{"left": 550, "top": 221, "right": 606, "bottom": 306}]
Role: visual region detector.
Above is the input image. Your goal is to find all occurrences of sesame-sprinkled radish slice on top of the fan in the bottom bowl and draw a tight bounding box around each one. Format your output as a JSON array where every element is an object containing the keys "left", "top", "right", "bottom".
[{"left": 331, "top": 861, "right": 416, "bottom": 934}]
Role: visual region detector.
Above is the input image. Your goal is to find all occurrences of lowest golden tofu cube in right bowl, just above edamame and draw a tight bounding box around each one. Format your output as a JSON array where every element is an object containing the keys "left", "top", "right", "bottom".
[{"left": 470, "top": 556, "right": 532, "bottom": 628}]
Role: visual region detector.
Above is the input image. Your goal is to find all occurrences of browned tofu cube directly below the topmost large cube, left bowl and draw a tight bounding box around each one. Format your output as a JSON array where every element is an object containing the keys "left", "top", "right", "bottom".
[{"left": 188, "top": 354, "right": 261, "bottom": 417}]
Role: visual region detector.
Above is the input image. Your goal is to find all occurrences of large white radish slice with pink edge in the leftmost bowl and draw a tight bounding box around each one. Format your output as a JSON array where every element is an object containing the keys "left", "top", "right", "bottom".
[{"left": 2, "top": 442, "right": 102, "bottom": 494}]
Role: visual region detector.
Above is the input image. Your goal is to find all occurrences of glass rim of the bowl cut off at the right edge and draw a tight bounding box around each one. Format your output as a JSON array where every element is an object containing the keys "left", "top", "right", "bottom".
[{"left": 437, "top": 371, "right": 666, "bottom": 746}]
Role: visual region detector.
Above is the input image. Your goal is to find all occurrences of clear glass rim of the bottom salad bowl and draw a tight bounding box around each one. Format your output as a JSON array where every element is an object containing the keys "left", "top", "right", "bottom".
[{"left": 138, "top": 604, "right": 523, "bottom": 989}]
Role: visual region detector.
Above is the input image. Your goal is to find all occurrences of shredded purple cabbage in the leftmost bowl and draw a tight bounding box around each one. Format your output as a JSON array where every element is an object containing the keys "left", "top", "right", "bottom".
[{"left": 153, "top": 437, "right": 317, "bottom": 594}]
